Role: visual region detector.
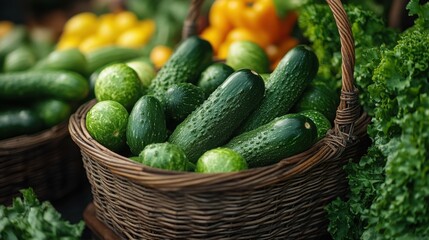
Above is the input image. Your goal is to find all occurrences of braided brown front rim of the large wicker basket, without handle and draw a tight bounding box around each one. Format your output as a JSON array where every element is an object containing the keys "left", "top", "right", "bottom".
[{"left": 69, "top": 99, "right": 368, "bottom": 192}]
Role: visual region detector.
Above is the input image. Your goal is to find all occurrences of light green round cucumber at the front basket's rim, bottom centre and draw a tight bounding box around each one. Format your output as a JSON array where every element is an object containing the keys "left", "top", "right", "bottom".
[{"left": 195, "top": 147, "right": 247, "bottom": 173}]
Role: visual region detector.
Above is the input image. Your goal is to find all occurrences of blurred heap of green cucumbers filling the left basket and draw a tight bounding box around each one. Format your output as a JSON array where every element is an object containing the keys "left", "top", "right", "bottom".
[{"left": 0, "top": 26, "right": 89, "bottom": 139}]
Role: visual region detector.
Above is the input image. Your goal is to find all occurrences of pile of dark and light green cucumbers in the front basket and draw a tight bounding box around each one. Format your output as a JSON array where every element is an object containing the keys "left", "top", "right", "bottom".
[{"left": 86, "top": 36, "right": 338, "bottom": 173}]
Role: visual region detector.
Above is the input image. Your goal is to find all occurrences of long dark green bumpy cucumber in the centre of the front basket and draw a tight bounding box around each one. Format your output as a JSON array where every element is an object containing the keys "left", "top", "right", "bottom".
[{"left": 169, "top": 69, "right": 265, "bottom": 163}]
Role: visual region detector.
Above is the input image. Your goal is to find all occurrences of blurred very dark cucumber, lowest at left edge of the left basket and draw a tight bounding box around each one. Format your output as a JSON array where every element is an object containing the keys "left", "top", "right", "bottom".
[{"left": 0, "top": 106, "right": 43, "bottom": 139}]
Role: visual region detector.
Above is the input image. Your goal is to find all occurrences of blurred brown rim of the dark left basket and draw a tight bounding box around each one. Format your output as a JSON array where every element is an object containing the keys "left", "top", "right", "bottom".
[{"left": 0, "top": 120, "right": 69, "bottom": 151}]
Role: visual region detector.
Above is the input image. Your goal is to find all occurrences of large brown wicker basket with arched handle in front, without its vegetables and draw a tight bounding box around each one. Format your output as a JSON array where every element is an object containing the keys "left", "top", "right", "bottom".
[{"left": 69, "top": 0, "right": 369, "bottom": 239}]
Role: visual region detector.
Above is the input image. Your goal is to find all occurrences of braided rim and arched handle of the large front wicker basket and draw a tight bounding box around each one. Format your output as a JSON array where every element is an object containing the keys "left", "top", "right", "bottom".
[{"left": 69, "top": 0, "right": 369, "bottom": 192}]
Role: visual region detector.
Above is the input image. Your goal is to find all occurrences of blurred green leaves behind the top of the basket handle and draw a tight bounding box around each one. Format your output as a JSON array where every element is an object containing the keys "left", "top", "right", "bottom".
[{"left": 298, "top": 3, "right": 397, "bottom": 89}]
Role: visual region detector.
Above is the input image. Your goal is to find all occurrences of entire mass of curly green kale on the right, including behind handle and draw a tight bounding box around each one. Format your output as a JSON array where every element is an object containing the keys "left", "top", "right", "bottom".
[{"left": 299, "top": 1, "right": 429, "bottom": 239}]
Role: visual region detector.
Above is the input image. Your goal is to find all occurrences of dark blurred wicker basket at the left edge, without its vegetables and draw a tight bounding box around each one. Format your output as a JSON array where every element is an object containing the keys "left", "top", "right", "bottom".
[{"left": 0, "top": 122, "right": 85, "bottom": 205}]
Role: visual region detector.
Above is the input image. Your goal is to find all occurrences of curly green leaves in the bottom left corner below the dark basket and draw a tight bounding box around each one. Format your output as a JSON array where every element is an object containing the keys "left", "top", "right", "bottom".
[{"left": 0, "top": 188, "right": 85, "bottom": 240}]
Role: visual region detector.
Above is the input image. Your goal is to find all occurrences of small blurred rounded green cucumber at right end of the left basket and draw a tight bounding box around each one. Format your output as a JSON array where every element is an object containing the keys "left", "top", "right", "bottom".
[{"left": 33, "top": 99, "right": 72, "bottom": 128}]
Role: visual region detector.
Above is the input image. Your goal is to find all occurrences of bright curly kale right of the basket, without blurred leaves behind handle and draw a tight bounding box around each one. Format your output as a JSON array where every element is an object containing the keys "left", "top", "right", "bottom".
[{"left": 328, "top": 0, "right": 429, "bottom": 239}]
